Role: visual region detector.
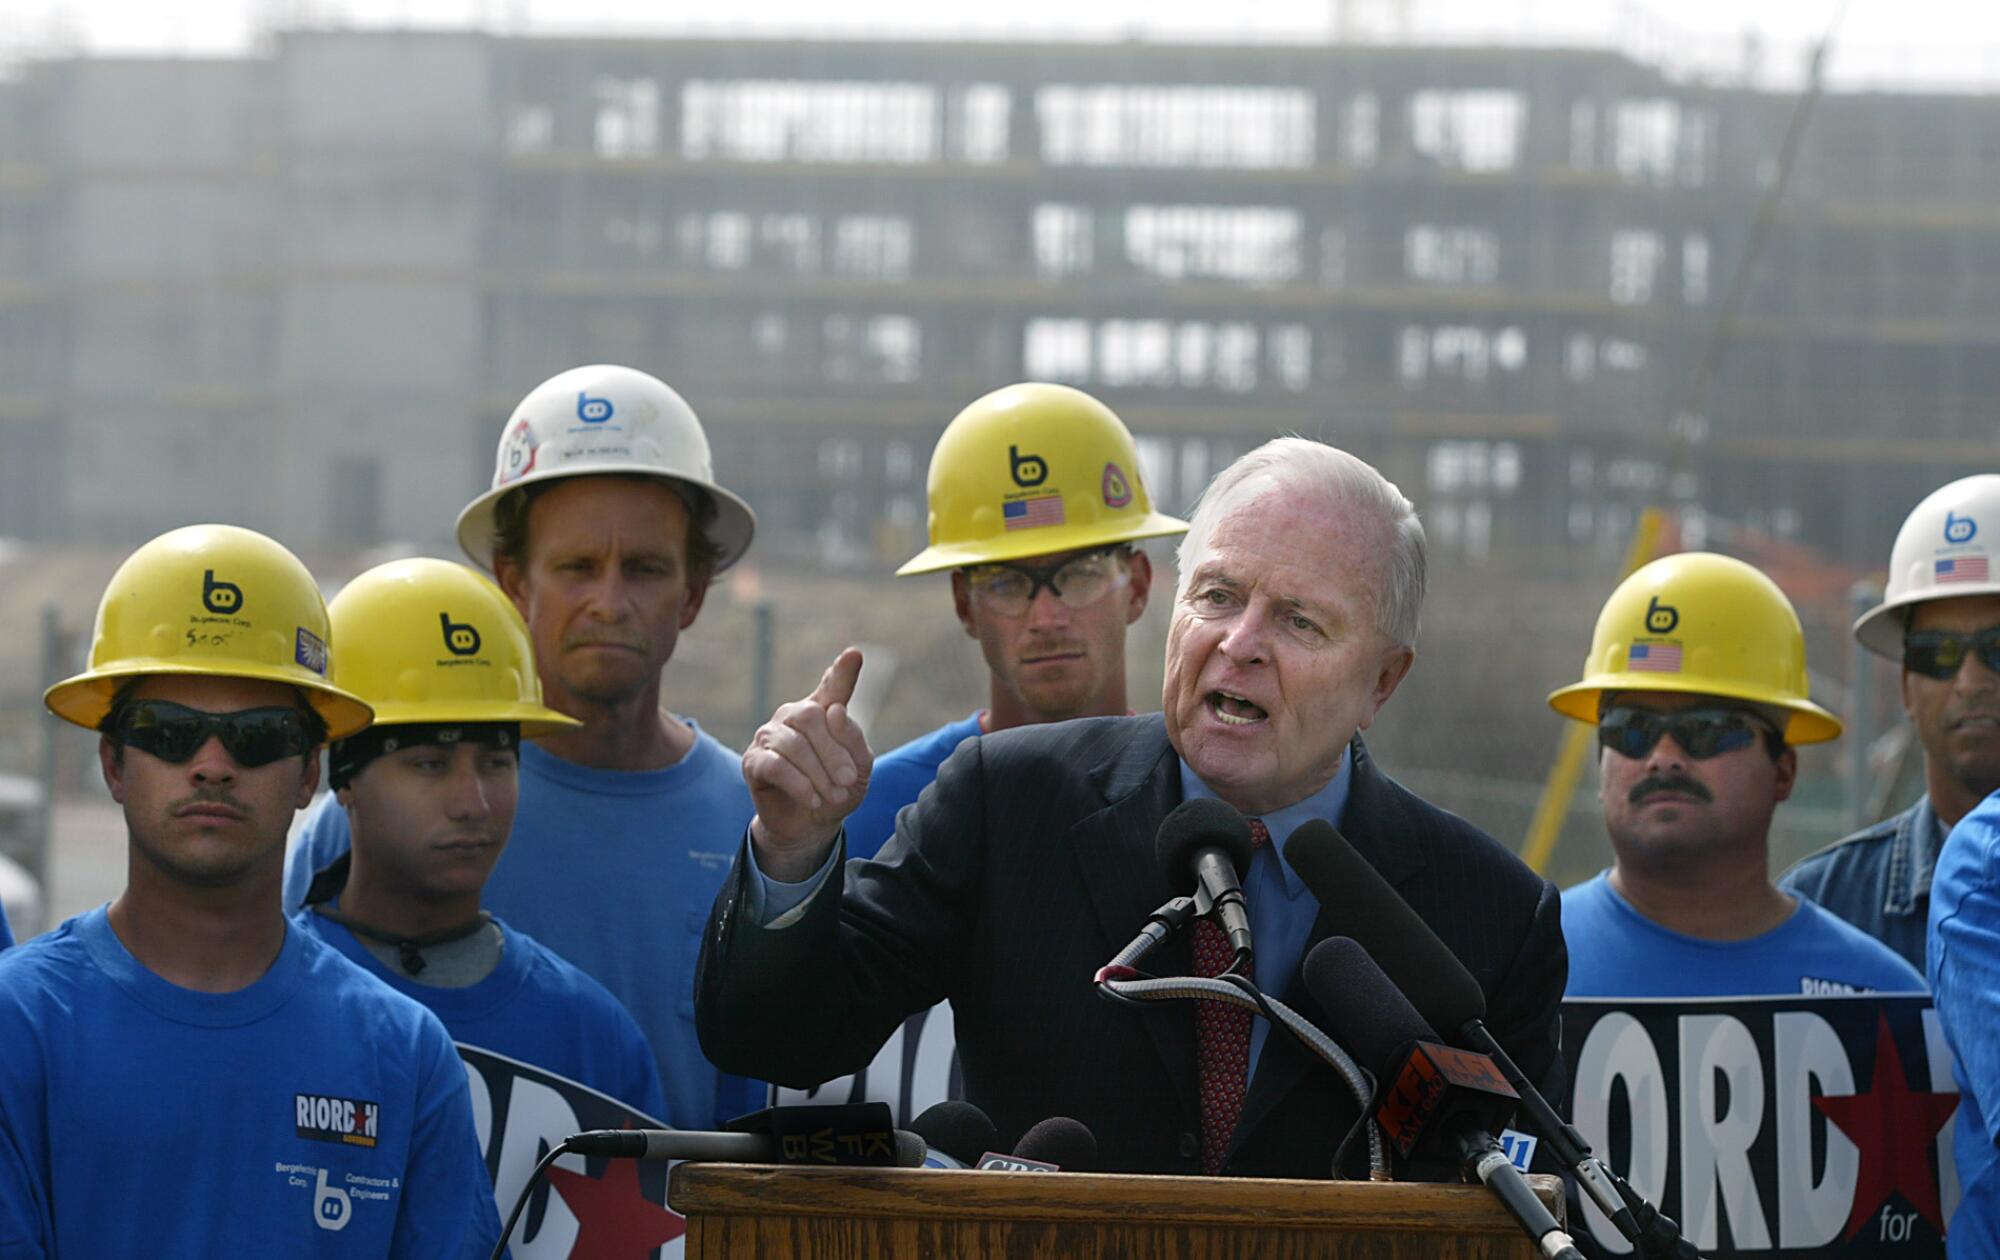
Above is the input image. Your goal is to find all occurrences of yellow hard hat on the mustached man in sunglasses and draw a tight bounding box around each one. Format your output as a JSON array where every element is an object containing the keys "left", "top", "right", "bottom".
[{"left": 1548, "top": 552, "right": 1840, "bottom": 744}]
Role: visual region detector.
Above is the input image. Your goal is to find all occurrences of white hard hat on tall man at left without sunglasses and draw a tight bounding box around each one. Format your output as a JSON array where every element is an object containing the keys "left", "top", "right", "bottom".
[{"left": 458, "top": 364, "right": 756, "bottom": 572}]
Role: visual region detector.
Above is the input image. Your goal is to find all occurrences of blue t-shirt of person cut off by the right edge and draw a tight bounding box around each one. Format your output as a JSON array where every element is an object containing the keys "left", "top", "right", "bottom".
[{"left": 1928, "top": 794, "right": 2000, "bottom": 1260}]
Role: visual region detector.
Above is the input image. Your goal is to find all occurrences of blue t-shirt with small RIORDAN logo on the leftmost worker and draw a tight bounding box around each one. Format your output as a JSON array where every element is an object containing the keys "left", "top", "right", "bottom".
[{"left": 0, "top": 908, "right": 500, "bottom": 1260}]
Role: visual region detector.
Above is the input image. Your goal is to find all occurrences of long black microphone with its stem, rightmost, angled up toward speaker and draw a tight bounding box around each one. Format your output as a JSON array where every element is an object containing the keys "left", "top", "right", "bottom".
[{"left": 1284, "top": 818, "right": 1656, "bottom": 1254}]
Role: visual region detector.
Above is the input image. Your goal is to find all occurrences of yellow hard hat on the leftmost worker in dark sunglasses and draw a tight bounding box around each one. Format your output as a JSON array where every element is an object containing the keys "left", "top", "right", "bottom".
[{"left": 42, "top": 524, "right": 370, "bottom": 740}]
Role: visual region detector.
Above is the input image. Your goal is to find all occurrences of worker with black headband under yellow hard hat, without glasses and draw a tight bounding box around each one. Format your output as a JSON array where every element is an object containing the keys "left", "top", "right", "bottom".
[{"left": 298, "top": 560, "right": 666, "bottom": 1128}]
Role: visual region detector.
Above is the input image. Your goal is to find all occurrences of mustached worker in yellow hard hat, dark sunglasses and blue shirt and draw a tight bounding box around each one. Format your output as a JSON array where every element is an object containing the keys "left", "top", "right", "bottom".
[{"left": 1548, "top": 552, "right": 1924, "bottom": 998}]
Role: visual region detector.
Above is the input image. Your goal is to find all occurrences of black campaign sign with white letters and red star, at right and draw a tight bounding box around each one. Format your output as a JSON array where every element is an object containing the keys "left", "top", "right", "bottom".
[{"left": 1562, "top": 996, "right": 1958, "bottom": 1258}]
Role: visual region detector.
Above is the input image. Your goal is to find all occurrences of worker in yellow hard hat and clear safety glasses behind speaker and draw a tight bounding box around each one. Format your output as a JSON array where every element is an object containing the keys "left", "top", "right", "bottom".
[{"left": 780, "top": 384, "right": 1188, "bottom": 1120}]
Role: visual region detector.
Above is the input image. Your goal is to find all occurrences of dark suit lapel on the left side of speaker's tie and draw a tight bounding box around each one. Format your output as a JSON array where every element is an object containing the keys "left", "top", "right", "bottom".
[{"left": 1068, "top": 714, "right": 1198, "bottom": 1114}]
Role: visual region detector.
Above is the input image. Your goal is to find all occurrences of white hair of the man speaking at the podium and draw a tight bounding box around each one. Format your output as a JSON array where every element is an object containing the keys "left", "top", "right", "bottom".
[{"left": 1176, "top": 438, "right": 1424, "bottom": 648}]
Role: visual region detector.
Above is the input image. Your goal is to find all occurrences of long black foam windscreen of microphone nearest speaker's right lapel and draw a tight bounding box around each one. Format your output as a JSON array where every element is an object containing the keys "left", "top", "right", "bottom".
[{"left": 1284, "top": 818, "right": 1486, "bottom": 1036}]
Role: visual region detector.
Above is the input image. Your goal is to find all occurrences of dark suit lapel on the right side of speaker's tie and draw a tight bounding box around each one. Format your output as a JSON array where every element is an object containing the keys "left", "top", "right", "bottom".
[{"left": 1224, "top": 736, "right": 1426, "bottom": 1150}]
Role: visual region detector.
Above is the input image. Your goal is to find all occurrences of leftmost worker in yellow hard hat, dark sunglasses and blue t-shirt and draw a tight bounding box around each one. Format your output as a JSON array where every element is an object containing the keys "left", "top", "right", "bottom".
[{"left": 0, "top": 526, "right": 500, "bottom": 1260}]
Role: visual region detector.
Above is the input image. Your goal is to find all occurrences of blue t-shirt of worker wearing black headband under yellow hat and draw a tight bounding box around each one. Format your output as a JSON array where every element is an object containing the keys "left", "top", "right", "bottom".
[{"left": 292, "top": 910, "right": 666, "bottom": 1128}]
